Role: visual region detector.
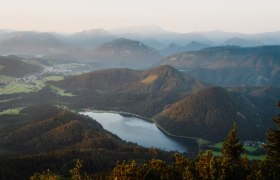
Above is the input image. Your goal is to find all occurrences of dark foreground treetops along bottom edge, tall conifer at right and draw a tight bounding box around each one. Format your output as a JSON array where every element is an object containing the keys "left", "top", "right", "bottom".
[{"left": 24, "top": 110, "right": 280, "bottom": 180}]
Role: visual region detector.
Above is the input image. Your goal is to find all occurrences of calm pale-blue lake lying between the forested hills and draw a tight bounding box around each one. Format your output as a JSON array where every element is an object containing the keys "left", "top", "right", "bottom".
[{"left": 81, "top": 111, "right": 197, "bottom": 152}]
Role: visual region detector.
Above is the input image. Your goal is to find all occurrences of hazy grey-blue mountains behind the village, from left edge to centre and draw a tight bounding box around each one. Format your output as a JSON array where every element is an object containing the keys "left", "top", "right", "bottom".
[{"left": 0, "top": 30, "right": 160, "bottom": 68}]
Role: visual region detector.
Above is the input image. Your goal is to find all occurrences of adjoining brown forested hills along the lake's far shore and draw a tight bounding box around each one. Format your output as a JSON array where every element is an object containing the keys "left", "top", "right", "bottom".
[{"left": 48, "top": 65, "right": 280, "bottom": 141}]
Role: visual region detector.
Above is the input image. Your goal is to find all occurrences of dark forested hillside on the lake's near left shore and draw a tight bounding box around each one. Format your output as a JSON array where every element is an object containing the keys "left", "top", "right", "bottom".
[{"left": 0, "top": 104, "right": 175, "bottom": 179}]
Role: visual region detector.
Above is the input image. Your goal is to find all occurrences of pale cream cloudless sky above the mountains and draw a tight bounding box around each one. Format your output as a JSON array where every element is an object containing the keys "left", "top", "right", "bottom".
[{"left": 0, "top": 0, "right": 280, "bottom": 34}]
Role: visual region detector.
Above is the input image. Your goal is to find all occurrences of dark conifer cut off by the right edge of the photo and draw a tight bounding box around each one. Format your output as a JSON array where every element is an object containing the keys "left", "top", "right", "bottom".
[{"left": 264, "top": 101, "right": 280, "bottom": 166}]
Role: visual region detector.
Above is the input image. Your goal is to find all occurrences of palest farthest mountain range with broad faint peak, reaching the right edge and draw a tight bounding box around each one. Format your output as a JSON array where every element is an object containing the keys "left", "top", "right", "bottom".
[{"left": 110, "top": 26, "right": 280, "bottom": 49}]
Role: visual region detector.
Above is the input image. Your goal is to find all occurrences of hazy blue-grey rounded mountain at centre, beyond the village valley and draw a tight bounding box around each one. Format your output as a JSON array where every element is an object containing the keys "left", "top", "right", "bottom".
[{"left": 88, "top": 38, "right": 160, "bottom": 69}]
